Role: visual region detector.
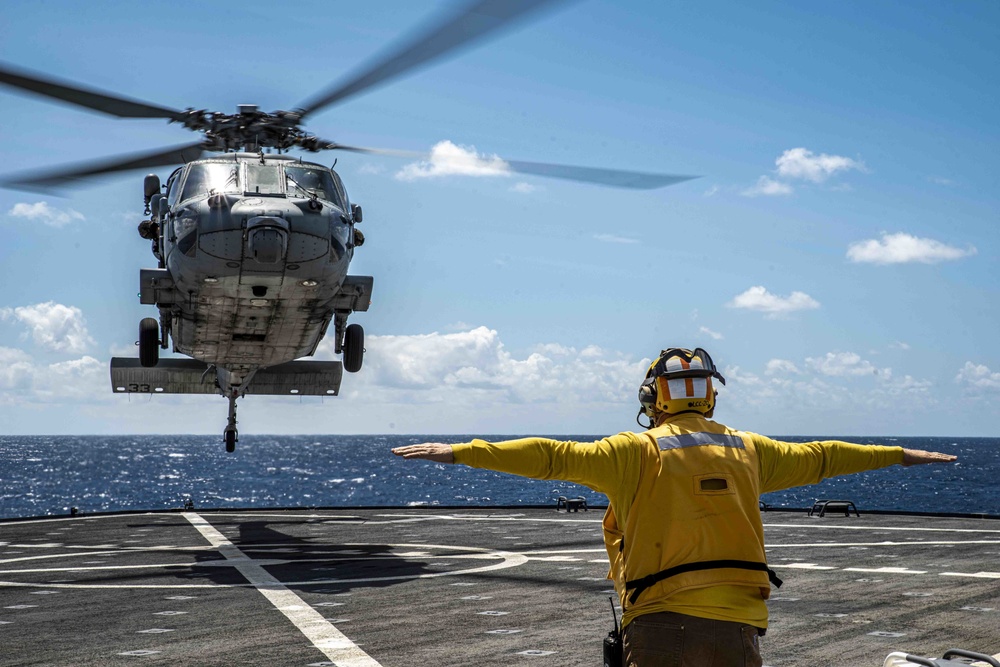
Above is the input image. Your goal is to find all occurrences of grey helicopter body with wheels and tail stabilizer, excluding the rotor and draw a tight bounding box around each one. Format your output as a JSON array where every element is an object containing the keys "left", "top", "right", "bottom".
[{"left": 112, "top": 153, "right": 373, "bottom": 444}]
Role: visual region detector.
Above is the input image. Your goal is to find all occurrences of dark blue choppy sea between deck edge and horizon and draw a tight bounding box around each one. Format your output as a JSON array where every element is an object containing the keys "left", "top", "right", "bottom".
[{"left": 0, "top": 435, "right": 1000, "bottom": 519}]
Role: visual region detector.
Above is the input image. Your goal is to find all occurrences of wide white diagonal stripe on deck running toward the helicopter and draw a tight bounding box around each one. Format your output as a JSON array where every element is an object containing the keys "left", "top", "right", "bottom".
[{"left": 182, "top": 512, "right": 381, "bottom": 667}]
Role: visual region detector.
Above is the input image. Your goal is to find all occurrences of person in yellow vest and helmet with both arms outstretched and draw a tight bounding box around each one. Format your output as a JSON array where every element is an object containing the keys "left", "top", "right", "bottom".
[{"left": 392, "top": 348, "right": 956, "bottom": 667}]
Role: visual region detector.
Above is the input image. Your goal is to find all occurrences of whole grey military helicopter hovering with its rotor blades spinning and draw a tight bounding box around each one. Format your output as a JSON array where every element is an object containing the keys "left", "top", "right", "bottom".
[{"left": 0, "top": 0, "right": 693, "bottom": 452}]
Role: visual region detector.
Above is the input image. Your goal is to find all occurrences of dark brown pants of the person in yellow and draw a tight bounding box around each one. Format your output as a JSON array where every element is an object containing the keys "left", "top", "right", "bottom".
[{"left": 623, "top": 612, "right": 763, "bottom": 667}]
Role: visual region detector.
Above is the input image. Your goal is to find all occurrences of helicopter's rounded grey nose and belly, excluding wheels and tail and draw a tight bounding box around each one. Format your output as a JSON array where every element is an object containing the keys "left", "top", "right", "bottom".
[{"left": 157, "top": 154, "right": 355, "bottom": 374}]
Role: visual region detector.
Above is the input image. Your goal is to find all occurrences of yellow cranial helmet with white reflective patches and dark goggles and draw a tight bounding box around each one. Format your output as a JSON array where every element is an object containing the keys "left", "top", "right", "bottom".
[{"left": 637, "top": 347, "right": 726, "bottom": 426}]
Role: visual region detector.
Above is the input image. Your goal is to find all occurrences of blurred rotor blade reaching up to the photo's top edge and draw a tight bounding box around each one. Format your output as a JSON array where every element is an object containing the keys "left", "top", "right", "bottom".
[{"left": 301, "top": 0, "right": 566, "bottom": 116}]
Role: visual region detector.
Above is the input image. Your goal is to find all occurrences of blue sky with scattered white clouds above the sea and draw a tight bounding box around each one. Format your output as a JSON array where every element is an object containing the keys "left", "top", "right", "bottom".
[{"left": 0, "top": 0, "right": 1000, "bottom": 437}]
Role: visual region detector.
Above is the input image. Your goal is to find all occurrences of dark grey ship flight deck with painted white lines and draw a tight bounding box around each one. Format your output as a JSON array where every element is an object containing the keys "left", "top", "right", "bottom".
[{"left": 0, "top": 508, "right": 1000, "bottom": 667}]
